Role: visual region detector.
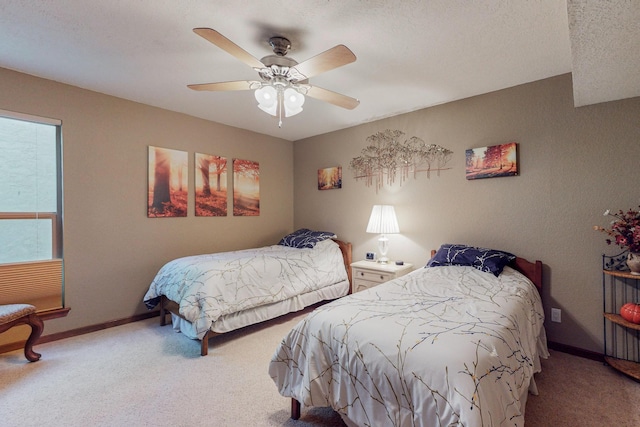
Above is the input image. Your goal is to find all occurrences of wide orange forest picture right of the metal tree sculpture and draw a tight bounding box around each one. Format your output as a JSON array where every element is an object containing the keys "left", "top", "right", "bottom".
[{"left": 465, "top": 142, "right": 518, "bottom": 179}]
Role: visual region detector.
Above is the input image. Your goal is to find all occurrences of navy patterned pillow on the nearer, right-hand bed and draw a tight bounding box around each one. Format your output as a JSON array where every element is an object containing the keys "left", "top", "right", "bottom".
[{"left": 426, "top": 243, "right": 516, "bottom": 277}]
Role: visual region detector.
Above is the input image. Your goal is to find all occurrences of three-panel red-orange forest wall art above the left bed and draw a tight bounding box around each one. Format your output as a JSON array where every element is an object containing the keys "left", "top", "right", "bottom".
[{"left": 147, "top": 146, "right": 260, "bottom": 218}]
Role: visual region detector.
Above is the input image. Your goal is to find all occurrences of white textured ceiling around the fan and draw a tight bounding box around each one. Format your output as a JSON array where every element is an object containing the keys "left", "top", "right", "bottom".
[{"left": 0, "top": 0, "right": 640, "bottom": 141}]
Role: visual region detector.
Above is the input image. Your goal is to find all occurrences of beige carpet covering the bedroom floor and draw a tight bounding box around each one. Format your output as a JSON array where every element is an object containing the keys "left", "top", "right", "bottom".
[{"left": 0, "top": 314, "right": 640, "bottom": 427}]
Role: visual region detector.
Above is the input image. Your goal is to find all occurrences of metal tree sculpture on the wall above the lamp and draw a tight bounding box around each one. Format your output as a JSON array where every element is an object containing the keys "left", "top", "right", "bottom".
[{"left": 349, "top": 129, "right": 453, "bottom": 191}]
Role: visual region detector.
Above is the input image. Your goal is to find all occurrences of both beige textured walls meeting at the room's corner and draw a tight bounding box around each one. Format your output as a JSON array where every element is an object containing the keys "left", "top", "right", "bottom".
[{"left": 5, "top": 69, "right": 640, "bottom": 351}]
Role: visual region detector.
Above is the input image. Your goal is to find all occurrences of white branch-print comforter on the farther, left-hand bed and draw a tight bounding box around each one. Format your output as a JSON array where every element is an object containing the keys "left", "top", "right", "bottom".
[{"left": 144, "top": 240, "right": 347, "bottom": 339}]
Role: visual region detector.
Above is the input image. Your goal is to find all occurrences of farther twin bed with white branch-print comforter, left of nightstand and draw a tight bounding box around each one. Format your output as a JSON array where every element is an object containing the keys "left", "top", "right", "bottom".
[{"left": 144, "top": 239, "right": 350, "bottom": 353}]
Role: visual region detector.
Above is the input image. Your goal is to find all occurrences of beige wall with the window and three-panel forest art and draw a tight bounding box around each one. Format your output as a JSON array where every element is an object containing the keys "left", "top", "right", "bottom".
[{"left": 0, "top": 69, "right": 293, "bottom": 338}]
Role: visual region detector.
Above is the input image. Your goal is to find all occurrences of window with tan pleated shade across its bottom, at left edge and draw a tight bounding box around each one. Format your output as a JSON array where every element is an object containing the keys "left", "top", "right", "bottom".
[{"left": 0, "top": 110, "right": 64, "bottom": 311}]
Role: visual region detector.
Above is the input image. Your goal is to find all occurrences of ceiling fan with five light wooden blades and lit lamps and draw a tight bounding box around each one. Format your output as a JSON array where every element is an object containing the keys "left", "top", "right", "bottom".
[{"left": 187, "top": 28, "right": 360, "bottom": 126}]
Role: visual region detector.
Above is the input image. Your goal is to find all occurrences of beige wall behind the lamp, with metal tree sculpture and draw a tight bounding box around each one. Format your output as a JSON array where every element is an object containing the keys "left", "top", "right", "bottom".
[{"left": 294, "top": 75, "right": 640, "bottom": 352}]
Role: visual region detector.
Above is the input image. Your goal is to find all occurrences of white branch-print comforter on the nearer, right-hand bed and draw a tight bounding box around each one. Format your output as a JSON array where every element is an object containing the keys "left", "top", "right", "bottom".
[{"left": 269, "top": 266, "right": 548, "bottom": 427}]
